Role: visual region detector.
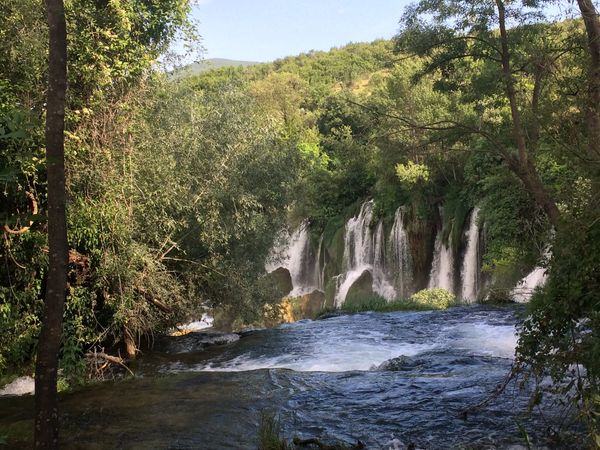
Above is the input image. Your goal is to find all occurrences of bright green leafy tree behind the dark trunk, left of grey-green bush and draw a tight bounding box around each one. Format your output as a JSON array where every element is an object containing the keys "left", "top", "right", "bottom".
[{"left": 0, "top": 0, "right": 193, "bottom": 383}]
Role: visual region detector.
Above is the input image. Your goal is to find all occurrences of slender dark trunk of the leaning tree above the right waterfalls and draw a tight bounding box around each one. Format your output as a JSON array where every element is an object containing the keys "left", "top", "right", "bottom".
[{"left": 496, "top": 0, "right": 560, "bottom": 227}]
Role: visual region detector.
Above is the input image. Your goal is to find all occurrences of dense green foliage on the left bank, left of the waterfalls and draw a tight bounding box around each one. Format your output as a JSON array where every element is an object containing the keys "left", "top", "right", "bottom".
[{"left": 0, "top": 0, "right": 301, "bottom": 376}]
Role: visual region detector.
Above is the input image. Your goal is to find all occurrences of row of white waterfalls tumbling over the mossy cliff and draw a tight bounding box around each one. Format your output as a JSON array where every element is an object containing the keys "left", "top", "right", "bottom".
[{"left": 266, "top": 201, "right": 488, "bottom": 307}]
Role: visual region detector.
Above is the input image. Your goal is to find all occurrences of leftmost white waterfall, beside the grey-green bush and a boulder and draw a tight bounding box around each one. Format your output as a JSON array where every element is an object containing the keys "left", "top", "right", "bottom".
[{"left": 265, "top": 219, "right": 323, "bottom": 297}]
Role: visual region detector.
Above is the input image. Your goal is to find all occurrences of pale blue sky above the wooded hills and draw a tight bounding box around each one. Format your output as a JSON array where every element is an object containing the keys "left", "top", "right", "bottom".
[{"left": 192, "top": 0, "right": 409, "bottom": 62}]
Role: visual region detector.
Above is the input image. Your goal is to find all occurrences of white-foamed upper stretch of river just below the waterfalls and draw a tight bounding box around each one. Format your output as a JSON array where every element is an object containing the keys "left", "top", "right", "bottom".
[{"left": 189, "top": 307, "right": 517, "bottom": 372}]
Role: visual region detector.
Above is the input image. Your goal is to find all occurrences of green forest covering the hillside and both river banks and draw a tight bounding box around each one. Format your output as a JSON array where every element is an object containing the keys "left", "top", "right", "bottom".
[{"left": 0, "top": 0, "right": 600, "bottom": 447}]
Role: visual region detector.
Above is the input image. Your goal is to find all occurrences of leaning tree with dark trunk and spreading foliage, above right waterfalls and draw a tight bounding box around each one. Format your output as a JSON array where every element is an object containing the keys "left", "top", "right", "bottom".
[{"left": 396, "top": 0, "right": 569, "bottom": 226}]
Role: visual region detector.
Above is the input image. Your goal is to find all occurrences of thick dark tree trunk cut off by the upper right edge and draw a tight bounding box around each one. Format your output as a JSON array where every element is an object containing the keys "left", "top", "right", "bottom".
[{"left": 577, "top": 0, "right": 600, "bottom": 164}]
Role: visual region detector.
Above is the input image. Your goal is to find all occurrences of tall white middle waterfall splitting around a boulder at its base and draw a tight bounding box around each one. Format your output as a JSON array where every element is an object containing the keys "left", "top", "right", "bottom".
[{"left": 335, "top": 200, "right": 396, "bottom": 307}]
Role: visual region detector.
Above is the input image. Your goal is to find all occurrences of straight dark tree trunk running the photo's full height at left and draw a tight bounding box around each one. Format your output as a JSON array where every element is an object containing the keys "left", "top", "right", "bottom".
[{"left": 34, "top": 0, "right": 68, "bottom": 449}]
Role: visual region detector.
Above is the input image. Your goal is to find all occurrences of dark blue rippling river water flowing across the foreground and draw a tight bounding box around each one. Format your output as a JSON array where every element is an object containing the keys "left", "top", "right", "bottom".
[{"left": 0, "top": 305, "right": 572, "bottom": 450}]
